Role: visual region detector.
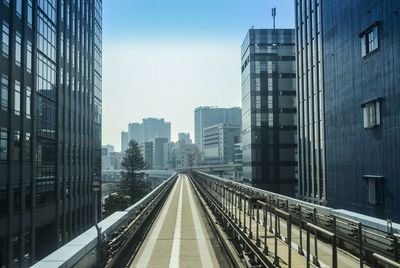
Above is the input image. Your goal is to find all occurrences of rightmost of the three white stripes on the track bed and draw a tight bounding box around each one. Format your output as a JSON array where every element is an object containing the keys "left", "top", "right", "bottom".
[{"left": 185, "top": 178, "right": 214, "bottom": 267}]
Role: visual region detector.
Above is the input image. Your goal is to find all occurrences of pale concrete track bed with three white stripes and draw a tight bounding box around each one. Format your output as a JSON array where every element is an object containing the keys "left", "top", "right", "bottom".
[{"left": 130, "top": 174, "right": 230, "bottom": 267}]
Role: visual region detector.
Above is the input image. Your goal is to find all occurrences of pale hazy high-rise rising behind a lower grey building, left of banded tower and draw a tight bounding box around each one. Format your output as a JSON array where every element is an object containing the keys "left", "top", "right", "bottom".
[{"left": 194, "top": 106, "right": 242, "bottom": 151}]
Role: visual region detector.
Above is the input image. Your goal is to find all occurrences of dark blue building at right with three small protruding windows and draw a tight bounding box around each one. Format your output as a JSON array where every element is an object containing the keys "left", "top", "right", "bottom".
[{"left": 296, "top": 0, "right": 400, "bottom": 222}]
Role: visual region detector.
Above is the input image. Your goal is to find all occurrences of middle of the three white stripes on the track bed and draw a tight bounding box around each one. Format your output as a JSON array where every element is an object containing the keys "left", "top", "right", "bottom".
[{"left": 169, "top": 177, "right": 183, "bottom": 268}]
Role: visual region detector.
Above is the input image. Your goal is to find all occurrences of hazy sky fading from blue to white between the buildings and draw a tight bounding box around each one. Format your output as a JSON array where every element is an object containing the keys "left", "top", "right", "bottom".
[{"left": 102, "top": 0, "right": 294, "bottom": 150}]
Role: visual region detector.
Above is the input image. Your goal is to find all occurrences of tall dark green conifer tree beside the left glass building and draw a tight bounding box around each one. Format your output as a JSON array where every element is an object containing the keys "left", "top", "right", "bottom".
[{"left": 120, "top": 140, "right": 151, "bottom": 203}]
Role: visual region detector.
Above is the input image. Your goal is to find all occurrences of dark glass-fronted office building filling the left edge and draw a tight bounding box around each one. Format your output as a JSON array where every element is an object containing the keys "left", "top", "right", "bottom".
[{"left": 0, "top": 0, "right": 102, "bottom": 267}]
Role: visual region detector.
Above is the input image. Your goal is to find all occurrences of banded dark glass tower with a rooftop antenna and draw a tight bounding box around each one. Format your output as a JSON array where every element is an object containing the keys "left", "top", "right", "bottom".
[{"left": 242, "top": 29, "right": 297, "bottom": 195}]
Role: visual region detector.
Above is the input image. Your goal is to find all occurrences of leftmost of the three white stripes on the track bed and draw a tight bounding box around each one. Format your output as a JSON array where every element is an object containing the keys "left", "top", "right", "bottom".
[{"left": 136, "top": 178, "right": 182, "bottom": 267}]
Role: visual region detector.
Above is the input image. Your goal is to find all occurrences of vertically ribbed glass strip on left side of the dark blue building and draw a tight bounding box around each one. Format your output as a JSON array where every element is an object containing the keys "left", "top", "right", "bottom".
[{"left": 295, "top": 0, "right": 326, "bottom": 204}]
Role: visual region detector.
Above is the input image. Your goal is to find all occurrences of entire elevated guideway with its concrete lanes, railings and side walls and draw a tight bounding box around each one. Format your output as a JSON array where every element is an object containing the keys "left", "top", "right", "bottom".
[{"left": 34, "top": 171, "right": 400, "bottom": 268}]
